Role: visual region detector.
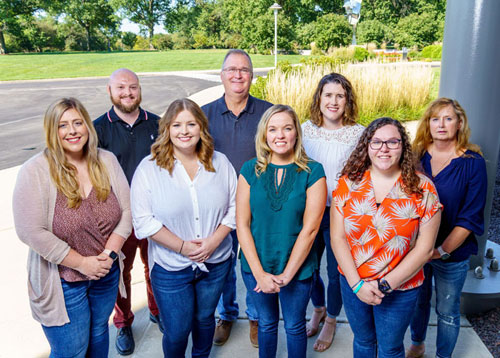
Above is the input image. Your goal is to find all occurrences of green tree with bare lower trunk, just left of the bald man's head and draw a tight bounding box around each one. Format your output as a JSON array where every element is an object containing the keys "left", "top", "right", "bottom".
[{"left": 61, "top": 0, "right": 118, "bottom": 51}]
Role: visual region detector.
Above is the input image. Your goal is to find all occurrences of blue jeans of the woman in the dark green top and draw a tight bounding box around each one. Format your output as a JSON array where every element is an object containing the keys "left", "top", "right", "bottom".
[{"left": 241, "top": 270, "right": 312, "bottom": 358}]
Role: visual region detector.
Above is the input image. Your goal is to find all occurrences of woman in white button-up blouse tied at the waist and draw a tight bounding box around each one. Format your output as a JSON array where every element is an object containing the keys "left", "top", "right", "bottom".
[{"left": 131, "top": 99, "right": 236, "bottom": 357}]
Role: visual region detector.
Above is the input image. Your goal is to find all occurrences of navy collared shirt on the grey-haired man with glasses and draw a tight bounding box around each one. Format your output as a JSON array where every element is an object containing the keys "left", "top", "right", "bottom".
[{"left": 201, "top": 96, "right": 272, "bottom": 174}]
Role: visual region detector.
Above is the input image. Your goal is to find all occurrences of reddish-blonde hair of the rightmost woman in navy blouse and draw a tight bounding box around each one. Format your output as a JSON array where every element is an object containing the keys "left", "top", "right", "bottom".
[{"left": 413, "top": 97, "right": 482, "bottom": 159}]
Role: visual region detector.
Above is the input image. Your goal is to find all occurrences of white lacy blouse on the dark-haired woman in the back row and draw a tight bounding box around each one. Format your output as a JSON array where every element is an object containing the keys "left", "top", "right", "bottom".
[{"left": 302, "top": 120, "right": 365, "bottom": 206}]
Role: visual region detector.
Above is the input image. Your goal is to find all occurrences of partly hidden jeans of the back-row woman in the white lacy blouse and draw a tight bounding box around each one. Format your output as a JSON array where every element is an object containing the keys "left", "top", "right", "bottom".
[{"left": 311, "top": 206, "right": 342, "bottom": 318}]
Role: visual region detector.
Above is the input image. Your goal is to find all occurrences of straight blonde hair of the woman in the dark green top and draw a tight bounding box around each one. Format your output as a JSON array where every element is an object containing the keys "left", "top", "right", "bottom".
[{"left": 255, "top": 104, "right": 310, "bottom": 176}]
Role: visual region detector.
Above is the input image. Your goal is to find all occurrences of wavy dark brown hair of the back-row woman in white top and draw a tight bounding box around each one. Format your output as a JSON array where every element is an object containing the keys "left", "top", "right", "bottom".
[{"left": 310, "top": 72, "right": 358, "bottom": 127}]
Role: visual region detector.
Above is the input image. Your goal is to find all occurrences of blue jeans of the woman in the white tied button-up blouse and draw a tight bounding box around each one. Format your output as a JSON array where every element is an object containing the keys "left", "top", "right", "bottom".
[{"left": 151, "top": 259, "right": 231, "bottom": 358}]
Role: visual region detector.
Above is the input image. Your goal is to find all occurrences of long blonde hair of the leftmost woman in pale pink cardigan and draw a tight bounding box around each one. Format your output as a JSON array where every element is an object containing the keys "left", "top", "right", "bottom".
[{"left": 43, "top": 97, "right": 111, "bottom": 208}]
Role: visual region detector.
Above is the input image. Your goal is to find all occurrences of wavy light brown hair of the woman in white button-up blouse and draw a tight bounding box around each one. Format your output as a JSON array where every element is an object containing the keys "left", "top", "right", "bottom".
[{"left": 151, "top": 98, "right": 215, "bottom": 175}]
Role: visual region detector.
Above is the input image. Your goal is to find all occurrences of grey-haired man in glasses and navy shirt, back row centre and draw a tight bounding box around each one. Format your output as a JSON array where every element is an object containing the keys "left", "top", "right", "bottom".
[{"left": 202, "top": 50, "right": 272, "bottom": 347}]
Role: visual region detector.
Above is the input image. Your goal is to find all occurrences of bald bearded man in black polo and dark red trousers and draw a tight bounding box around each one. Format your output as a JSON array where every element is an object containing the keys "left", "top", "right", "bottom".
[{"left": 94, "top": 68, "right": 162, "bottom": 355}]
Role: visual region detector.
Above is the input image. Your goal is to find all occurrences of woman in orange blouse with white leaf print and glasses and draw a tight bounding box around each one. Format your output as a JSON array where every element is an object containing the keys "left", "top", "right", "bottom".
[{"left": 331, "top": 117, "right": 441, "bottom": 358}]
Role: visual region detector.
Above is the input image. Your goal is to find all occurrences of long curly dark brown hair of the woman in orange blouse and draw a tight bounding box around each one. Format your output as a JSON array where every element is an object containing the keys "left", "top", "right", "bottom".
[{"left": 341, "top": 117, "right": 422, "bottom": 195}]
